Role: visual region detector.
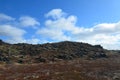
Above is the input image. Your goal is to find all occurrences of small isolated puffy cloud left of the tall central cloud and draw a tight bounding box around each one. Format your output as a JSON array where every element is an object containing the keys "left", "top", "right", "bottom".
[{"left": 19, "top": 16, "right": 40, "bottom": 27}]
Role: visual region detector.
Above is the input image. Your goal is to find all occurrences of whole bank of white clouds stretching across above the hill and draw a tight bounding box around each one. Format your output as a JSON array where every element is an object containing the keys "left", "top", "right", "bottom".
[{"left": 0, "top": 9, "right": 120, "bottom": 49}]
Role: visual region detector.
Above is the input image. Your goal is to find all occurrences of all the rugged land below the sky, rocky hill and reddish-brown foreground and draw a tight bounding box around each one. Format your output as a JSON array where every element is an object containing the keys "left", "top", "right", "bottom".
[{"left": 0, "top": 40, "right": 120, "bottom": 80}]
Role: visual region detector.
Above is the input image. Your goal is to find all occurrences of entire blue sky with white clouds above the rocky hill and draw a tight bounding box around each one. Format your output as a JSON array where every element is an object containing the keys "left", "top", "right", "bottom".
[{"left": 0, "top": 0, "right": 120, "bottom": 49}]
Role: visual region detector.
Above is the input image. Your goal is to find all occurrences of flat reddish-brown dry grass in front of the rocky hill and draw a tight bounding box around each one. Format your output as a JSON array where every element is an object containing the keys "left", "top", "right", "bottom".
[{"left": 0, "top": 59, "right": 120, "bottom": 80}]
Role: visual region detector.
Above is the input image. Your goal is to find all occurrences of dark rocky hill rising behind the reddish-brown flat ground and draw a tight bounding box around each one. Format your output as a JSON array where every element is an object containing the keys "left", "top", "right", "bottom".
[{"left": 0, "top": 40, "right": 107, "bottom": 63}]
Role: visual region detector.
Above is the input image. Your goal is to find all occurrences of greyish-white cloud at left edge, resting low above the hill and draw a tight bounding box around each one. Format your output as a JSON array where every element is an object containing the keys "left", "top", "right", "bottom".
[{"left": 0, "top": 25, "right": 40, "bottom": 44}]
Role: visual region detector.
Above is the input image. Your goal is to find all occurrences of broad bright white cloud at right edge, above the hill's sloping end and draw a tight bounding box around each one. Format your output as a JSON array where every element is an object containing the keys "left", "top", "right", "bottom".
[{"left": 74, "top": 22, "right": 120, "bottom": 49}]
